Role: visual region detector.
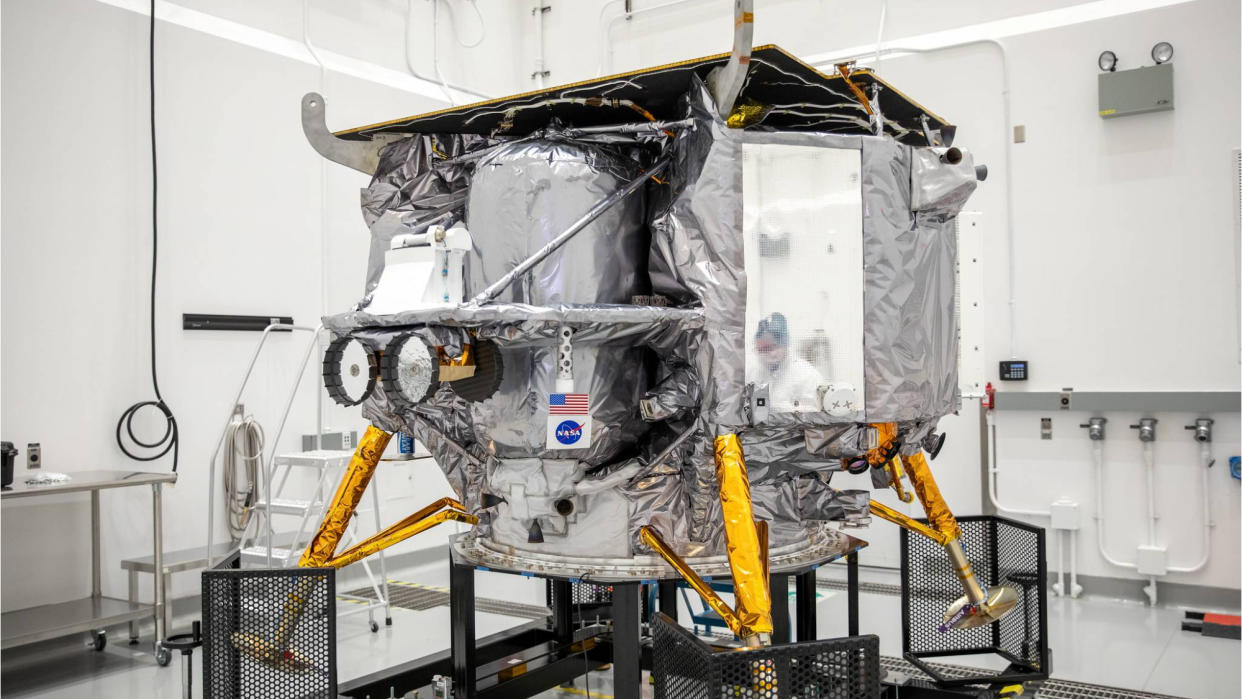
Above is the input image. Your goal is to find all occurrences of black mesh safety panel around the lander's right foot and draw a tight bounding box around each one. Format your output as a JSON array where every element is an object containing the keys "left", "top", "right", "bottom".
[{"left": 902, "top": 515, "right": 1051, "bottom": 684}]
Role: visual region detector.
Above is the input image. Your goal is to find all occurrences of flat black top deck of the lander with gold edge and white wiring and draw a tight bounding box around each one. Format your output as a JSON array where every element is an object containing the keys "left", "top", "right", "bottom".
[{"left": 335, "top": 45, "right": 948, "bottom": 145}]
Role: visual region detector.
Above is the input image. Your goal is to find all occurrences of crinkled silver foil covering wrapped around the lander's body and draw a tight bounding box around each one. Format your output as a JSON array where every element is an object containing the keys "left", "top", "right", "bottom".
[{"left": 324, "top": 72, "right": 975, "bottom": 574}]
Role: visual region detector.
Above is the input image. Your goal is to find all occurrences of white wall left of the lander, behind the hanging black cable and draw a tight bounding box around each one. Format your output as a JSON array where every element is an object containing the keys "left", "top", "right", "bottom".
[{"left": 0, "top": 0, "right": 524, "bottom": 610}]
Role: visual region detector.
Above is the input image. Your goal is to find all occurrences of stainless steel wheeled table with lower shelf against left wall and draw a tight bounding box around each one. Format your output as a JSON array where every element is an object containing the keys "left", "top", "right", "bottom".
[{"left": 0, "top": 471, "right": 176, "bottom": 664}]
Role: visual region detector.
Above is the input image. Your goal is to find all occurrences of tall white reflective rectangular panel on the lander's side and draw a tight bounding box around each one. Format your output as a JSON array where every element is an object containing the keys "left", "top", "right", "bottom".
[{"left": 741, "top": 143, "right": 864, "bottom": 420}]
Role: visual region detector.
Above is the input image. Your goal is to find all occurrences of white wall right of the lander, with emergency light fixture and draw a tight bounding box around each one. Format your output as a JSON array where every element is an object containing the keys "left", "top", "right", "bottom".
[{"left": 548, "top": 0, "right": 1240, "bottom": 589}]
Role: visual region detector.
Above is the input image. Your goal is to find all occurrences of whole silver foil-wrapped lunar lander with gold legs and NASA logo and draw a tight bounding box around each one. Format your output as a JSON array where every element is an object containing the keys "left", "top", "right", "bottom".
[{"left": 221, "top": 2, "right": 1017, "bottom": 695}]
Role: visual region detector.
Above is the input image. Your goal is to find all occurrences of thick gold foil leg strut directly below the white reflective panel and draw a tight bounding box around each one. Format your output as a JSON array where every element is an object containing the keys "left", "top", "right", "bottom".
[{"left": 715, "top": 435, "right": 773, "bottom": 638}]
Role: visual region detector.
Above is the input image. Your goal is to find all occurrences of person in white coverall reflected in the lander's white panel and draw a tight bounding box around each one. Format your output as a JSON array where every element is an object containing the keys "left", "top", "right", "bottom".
[{"left": 748, "top": 313, "right": 823, "bottom": 412}]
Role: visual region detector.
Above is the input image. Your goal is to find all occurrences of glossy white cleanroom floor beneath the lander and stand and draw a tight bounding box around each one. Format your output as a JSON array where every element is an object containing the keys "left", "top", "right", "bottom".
[{"left": 0, "top": 566, "right": 1242, "bottom": 699}]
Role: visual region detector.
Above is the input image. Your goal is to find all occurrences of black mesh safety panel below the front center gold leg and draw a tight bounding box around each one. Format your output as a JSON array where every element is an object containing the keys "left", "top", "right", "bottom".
[{"left": 652, "top": 612, "right": 881, "bottom": 699}]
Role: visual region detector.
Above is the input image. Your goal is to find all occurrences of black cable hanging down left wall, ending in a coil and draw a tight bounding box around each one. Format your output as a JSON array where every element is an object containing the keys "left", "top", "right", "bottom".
[{"left": 117, "top": 0, "right": 180, "bottom": 473}]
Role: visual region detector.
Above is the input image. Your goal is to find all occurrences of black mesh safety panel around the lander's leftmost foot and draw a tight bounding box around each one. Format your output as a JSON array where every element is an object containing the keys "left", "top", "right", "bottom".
[{"left": 202, "top": 569, "right": 337, "bottom": 699}]
